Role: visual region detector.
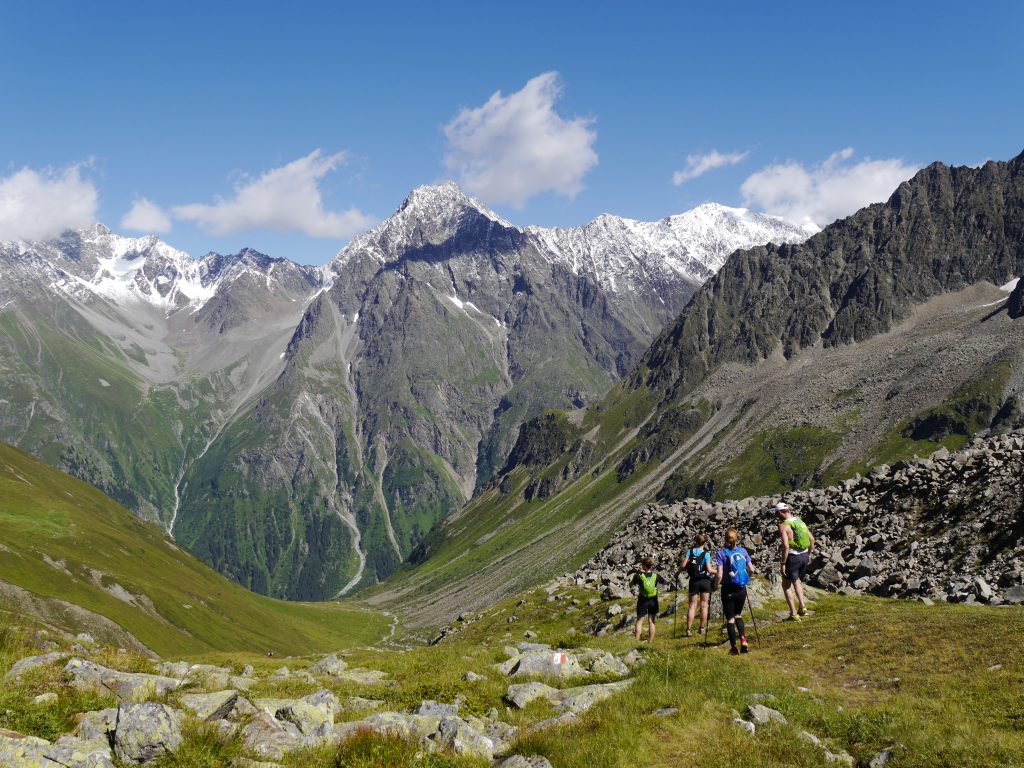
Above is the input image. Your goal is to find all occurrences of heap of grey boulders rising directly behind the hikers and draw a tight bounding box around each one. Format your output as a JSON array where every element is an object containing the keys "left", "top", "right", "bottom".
[{"left": 573, "top": 432, "right": 1024, "bottom": 605}]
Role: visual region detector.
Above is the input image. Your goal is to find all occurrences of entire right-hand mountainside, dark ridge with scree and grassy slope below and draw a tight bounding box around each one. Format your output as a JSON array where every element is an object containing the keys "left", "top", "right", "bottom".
[{"left": 372, "top": 150, "right": 1024, "bottom": 623}]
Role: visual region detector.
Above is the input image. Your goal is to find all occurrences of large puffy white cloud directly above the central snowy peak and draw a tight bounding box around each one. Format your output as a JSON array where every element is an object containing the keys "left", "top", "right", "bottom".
[{"left": 444, "top": 72, "right": 597, "bottom": 208}]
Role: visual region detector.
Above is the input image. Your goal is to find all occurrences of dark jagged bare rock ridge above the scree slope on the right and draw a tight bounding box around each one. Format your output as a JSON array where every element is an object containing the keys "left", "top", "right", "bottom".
[{"left": 631, "top": 155, "right": 1024, "bottom": 396}]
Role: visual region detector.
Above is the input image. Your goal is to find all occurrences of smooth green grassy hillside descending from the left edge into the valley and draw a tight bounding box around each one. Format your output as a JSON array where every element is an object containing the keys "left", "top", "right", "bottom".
[{"left": 0, "top": 443, "right": 388, "bottom": 654}]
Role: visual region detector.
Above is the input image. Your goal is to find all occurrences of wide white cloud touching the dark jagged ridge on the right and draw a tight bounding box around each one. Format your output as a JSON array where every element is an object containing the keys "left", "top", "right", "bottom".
[{"left": 739, "top": 147, "right": 920, "bottom": 228}]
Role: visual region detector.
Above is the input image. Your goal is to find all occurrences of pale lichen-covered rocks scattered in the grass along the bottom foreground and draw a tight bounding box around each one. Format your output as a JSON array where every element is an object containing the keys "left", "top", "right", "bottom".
[{"left": 0, "top": 633, "right": 644, "bottom": 768}]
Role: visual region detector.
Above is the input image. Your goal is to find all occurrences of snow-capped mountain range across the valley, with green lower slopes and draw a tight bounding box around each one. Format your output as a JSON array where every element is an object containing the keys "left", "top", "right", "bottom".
[{"left": 0, "top": 184, "right": 806, "bottom": 599}]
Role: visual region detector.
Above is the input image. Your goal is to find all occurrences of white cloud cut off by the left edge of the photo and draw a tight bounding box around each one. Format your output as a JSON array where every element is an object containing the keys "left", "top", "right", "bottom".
[{"left": 0, "top": 165, "right": 99, "bottom": 240}]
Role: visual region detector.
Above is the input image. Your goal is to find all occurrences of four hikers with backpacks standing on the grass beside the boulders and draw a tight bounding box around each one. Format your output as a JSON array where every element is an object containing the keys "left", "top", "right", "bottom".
[{"left": 630, "top": 502, "right": 814, "bottom": 655}]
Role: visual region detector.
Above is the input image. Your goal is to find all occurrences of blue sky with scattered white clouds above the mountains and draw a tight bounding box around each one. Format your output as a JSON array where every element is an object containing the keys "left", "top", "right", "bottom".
[{"left": 0, "top": 0, "right": 1024, "bottom": 263}]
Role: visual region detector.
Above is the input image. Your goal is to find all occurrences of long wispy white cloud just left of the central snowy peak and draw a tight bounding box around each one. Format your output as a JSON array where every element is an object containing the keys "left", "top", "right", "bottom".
[{"left": 174, "top": 150, "right": 374, "bottom": 239}]
